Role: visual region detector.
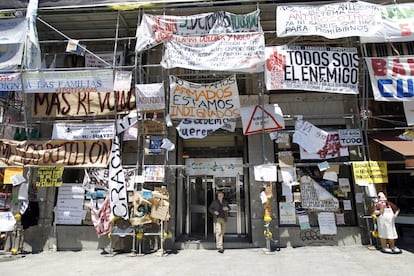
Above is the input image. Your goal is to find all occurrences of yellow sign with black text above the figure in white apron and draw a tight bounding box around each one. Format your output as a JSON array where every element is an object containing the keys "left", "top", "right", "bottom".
[{"left": 352, "top": 161, "right": 388, "bottom": 186}]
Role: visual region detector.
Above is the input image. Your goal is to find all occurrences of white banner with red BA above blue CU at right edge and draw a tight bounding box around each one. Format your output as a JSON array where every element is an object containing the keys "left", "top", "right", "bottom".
[{"left": 365, "top": 56, "right": 414, "bottom": 102}]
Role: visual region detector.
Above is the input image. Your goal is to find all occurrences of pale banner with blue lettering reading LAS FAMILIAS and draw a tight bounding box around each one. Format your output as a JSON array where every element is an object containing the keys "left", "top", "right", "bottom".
[{"left": 23, "top": 69, "right": 114, "bottom": 93}]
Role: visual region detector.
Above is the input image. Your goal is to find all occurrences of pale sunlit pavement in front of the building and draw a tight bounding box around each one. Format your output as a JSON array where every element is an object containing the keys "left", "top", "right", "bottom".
[{"left": 0, "top": 246, "right": 414, "bottom": 276}]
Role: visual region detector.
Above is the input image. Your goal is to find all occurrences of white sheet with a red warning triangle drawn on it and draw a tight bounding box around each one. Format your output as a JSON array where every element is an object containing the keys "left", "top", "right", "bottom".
[{"left": 241, "top": 104, "right": 285, "bottom": 135}]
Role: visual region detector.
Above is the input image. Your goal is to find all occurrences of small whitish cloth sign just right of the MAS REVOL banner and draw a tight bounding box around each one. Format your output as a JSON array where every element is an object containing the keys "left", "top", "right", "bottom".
[{"left": 135, "top": 83, "right": 165, "bottom": 111}]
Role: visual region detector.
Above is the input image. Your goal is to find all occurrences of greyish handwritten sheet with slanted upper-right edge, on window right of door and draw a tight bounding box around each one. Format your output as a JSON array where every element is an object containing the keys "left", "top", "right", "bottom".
[{"left": 300, "top": 175, "right": 339, "bottom": 212}]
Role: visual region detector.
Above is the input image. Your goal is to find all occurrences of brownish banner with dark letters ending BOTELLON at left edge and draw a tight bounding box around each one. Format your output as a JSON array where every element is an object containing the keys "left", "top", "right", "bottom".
[{"left": 0, "top": 139, "right": 111, "bottom": 168}]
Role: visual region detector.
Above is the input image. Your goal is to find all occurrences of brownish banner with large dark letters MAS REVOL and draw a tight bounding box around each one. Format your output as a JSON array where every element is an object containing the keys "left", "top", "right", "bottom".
[{"left": 32, "top": 89, "right": 136, "bottom": 118}]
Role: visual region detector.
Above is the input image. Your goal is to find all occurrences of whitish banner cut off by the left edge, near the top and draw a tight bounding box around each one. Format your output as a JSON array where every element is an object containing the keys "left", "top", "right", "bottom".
[{"left": 0, "top": 18, "right": 27, "bottom": 70}]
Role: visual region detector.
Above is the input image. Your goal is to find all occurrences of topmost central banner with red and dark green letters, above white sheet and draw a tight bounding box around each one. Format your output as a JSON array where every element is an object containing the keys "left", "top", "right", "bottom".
[{"left": 135, "top": 10, "right": 262, "bottom": 52}]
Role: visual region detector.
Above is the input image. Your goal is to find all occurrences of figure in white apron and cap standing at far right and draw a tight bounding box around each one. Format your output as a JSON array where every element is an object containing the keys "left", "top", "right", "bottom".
[{"left": 374, "top": 192, "right": 401, "bottom": 254}]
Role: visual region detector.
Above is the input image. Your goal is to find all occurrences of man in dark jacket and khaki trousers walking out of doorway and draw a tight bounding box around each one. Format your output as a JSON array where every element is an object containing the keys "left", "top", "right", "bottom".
[{"left": 208, "top": 191, "right": 230, "bottom": 253}]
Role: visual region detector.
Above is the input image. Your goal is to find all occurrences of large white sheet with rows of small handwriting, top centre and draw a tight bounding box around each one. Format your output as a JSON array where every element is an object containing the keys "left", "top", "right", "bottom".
[{"left": 161, "top": 33, "right": 265, "bottom": 73}]
